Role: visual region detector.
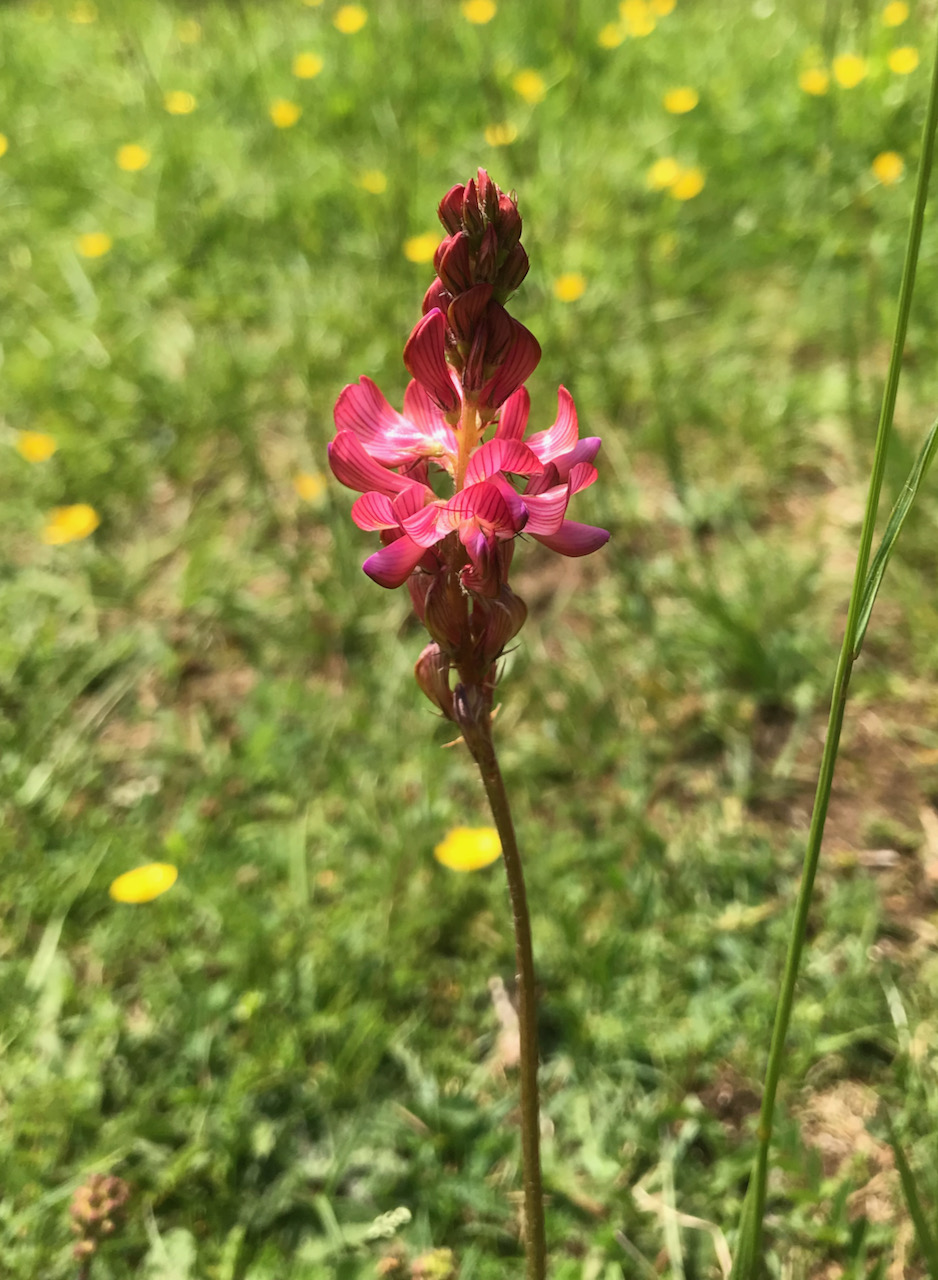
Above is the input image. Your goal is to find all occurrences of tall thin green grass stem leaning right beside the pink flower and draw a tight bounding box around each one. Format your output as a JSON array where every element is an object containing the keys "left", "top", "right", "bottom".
[{"left": 733, "top": 17, "right": 938, "bottom": 1280}]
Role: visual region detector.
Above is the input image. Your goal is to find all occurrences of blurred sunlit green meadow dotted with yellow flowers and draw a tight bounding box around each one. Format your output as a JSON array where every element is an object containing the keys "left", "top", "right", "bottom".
[{"left": 0, "top": 0, "right": 938, "bottom": 1280}]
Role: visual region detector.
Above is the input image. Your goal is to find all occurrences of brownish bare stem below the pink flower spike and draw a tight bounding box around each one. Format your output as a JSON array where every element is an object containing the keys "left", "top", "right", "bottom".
[{"left": 462, "top": 705, "right": 548, "bottom": 1280}]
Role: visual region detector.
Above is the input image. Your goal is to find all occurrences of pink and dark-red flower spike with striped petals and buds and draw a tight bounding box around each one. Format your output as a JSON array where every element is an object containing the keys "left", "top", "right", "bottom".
[{"left": 329, "top": 169, "right": 609, "bottom": 721}]
